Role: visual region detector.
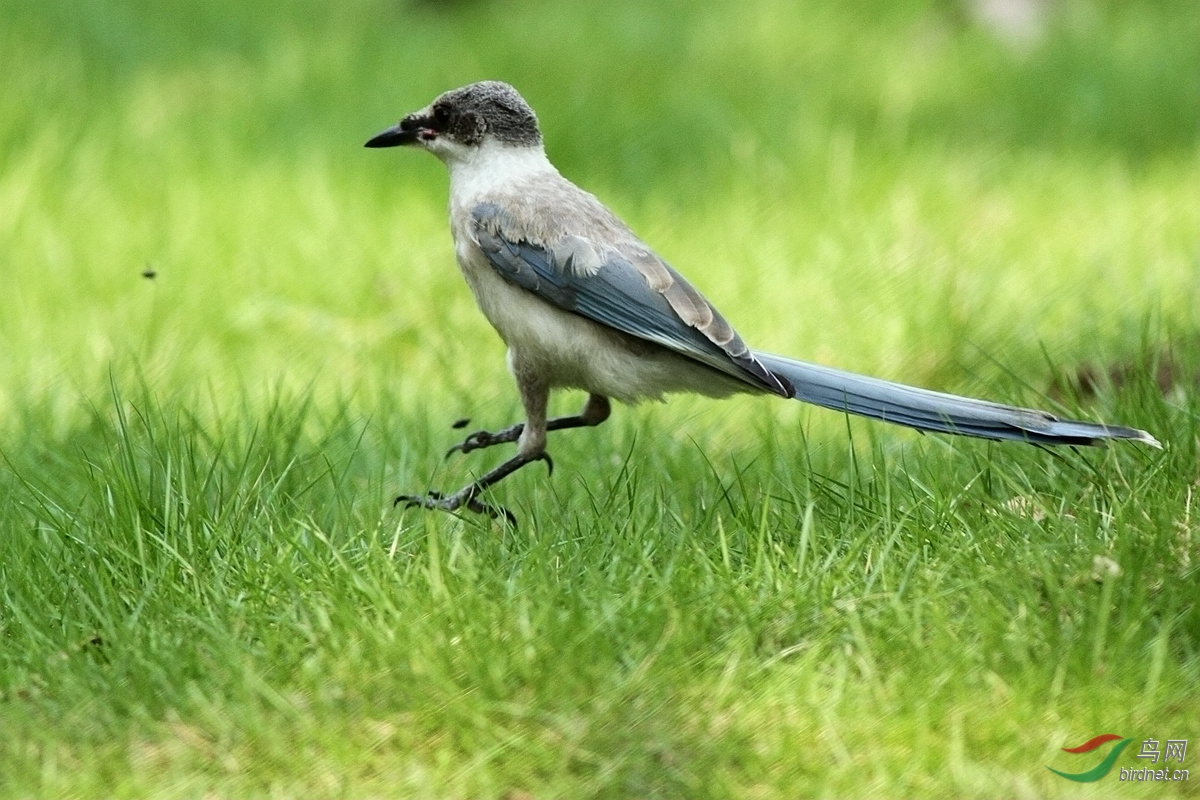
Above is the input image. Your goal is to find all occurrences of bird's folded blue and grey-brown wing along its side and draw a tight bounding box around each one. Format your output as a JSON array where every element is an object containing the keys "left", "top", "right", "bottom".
[{"left": 472, "top": 201, "right": 793, "bottom": 397}]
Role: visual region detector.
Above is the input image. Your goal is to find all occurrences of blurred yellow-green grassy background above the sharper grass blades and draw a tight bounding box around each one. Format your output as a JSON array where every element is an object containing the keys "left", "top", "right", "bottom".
[{"left": 0, "top": 1, "right": 1200, "bottom": 424}]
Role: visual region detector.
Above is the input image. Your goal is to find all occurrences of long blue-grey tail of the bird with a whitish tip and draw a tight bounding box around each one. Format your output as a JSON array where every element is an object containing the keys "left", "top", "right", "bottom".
[{"left": 754, "top": 353, "right": 1162, "bottom": 447}]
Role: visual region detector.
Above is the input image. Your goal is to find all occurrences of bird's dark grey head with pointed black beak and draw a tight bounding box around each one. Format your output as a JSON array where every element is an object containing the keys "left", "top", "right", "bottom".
[{"left": 366, "top": 80, "right": 541, "bottom": 161}]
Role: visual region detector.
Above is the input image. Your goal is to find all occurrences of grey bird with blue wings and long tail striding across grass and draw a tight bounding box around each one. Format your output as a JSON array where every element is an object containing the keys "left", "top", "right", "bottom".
[{"left": 365, "top": 80, "right": 1160, "bottom": 524}]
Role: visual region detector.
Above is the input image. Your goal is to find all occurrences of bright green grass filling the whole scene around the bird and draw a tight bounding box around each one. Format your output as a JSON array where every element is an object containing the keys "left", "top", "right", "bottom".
[{"left": 0, "top": 0, "right": 1200, "bottom": 800}]
